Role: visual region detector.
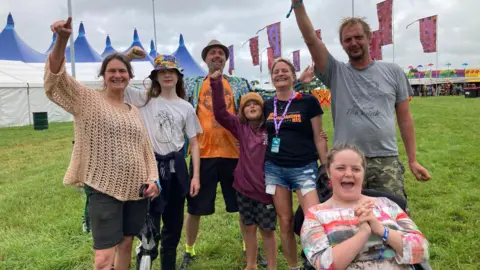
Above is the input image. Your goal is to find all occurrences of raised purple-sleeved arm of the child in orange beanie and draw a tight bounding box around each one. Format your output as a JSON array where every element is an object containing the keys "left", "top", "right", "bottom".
[{"left": 210, "top": 72, "right": 240, "bottom": 138}]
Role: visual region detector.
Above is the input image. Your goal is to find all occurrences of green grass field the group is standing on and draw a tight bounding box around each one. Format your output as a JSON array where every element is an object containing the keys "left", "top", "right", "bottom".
[{"left": 0, "top": 97, "right": 480, "bottom": 270}]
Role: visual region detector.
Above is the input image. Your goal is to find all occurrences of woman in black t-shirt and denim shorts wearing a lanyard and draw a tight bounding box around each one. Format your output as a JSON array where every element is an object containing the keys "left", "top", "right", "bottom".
[{"left": 264, "top": 58, "right": 327, "bottom": 269}]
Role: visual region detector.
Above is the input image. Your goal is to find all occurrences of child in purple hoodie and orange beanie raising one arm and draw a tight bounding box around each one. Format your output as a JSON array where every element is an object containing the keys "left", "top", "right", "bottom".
[{"left": 210, "top": 71, "right": 277, "bottom": 270}]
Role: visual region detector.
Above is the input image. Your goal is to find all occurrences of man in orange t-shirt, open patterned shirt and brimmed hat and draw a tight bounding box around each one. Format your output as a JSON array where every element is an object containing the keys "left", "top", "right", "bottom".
[{"left": 180, "top": 40, "right": 266, "bottom": 269}]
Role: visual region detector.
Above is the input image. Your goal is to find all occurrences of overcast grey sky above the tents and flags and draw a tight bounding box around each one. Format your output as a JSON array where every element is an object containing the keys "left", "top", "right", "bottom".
[{"left": 0, "top": 0, "right": 480, "bottom": 85}]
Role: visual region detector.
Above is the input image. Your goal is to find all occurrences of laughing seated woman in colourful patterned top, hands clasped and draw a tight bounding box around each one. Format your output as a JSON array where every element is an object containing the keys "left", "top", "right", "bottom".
[{"left": 301, "top": 145, "right": 429, "bottom": 269}]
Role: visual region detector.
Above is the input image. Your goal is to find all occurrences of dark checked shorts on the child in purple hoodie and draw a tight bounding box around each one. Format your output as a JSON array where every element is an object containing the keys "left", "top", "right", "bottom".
[{"left": 237, "top": 192, "right": 277, "bottom": 232}]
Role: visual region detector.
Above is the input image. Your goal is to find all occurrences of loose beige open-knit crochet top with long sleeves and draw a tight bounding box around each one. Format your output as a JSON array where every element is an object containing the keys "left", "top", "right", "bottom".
[{"left": 44, "top": 60, "right": 158, "bottom": 201}]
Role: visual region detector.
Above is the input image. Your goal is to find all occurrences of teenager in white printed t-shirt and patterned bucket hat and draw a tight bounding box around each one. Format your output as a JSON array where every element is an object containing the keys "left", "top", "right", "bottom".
[{"left": 125, "top": 48, "right": 202, "bottom": 269}]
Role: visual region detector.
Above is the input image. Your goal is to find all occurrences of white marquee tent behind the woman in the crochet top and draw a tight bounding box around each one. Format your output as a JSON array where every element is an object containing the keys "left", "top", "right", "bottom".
[{"left": 0, "top": 60, "right": 152, "bottom": 127}]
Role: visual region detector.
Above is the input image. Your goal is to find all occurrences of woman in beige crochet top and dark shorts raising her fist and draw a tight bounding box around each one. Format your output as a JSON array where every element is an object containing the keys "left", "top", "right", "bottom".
[{"left": 44, "top": 18, "right": 161, "bottom": 269}]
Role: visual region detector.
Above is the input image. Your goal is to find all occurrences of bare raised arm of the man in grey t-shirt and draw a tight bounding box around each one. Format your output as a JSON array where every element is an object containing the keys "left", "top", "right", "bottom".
[{"left": 292, "top": 0, "right": 328, "bottom": 74}]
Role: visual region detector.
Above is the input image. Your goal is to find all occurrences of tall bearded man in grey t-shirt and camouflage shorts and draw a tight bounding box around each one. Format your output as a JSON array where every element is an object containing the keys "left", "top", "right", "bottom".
[{"left": 292, "top": 0, "right": 430, "bottom": 199}]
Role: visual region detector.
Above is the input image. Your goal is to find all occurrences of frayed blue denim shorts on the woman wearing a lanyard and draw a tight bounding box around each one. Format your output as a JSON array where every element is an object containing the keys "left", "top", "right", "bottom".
[{"left": 265, "top": 161, "right": 318, "bottom": 195}]
